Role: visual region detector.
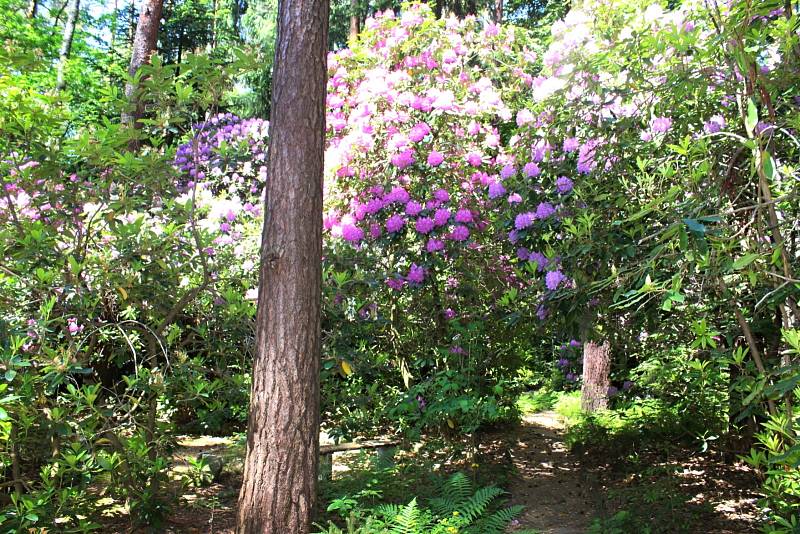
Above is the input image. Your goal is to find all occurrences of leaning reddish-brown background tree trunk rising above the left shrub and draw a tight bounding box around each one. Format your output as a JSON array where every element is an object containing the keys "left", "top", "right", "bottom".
[{"left": 122, "top": 0, "right": 164, "bottom": 133}]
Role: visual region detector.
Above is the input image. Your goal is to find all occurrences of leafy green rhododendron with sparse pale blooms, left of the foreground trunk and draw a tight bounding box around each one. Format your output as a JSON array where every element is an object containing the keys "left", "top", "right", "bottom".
[{"left": 0, "top": 57, "right": 266, "bottom": 531}]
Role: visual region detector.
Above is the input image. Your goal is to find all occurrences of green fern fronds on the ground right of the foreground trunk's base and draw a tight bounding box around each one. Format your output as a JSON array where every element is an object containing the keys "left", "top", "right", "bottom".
[{"left": 320, "top": 473, "right": 522, "bottom": 534}]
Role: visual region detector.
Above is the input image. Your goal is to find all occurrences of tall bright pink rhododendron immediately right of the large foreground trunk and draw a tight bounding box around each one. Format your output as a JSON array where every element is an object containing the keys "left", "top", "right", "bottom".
[{"left": 324, "top": 5, "right": 568, "bottom": 438}]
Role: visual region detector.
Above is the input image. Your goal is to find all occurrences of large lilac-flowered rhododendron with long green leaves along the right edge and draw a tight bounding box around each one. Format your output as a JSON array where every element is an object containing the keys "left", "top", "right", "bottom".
[{"left": 496, "top": 0, "right": 800, "bottom": 530}]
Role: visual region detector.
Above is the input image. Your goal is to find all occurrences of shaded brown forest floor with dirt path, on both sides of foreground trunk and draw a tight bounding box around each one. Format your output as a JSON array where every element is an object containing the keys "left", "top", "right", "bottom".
[{"left": 105, "top": 411, "right": 759, "bottom": 534}]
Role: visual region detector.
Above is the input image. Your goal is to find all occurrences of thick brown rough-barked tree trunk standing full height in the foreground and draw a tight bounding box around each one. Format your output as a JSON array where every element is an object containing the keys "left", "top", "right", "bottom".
[{"left": 237, "top": 0, "right": 329, "bottom": 534}]
